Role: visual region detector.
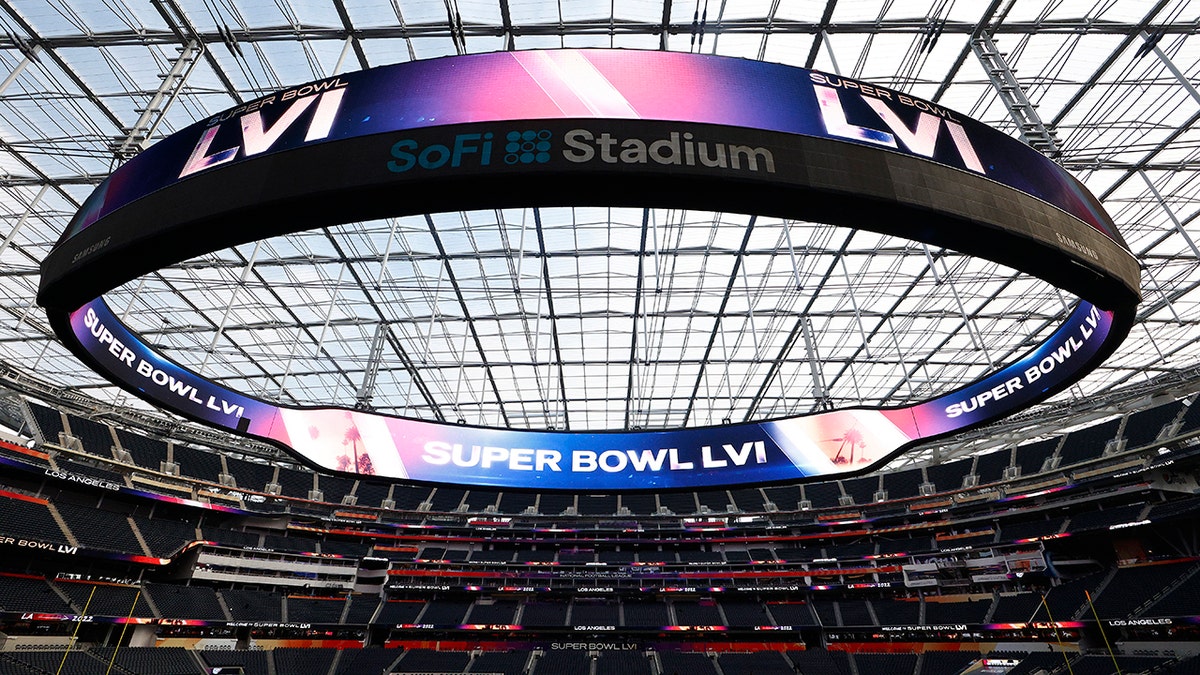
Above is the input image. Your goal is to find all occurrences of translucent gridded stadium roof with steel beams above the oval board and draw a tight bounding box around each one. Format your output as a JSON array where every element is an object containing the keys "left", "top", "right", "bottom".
[{"left": 0, "top": 0, "right": 1200, "bottom": 468}]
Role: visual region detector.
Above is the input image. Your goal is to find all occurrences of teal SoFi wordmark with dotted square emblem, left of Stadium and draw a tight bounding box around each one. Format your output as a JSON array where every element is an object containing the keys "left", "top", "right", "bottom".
[{"left": 388, "top": 129, "right": 552, "bottom": 173}]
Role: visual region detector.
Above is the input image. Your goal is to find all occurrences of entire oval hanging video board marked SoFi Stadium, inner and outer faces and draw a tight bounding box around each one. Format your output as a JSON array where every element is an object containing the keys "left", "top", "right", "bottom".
[{"left": 38, "top": 50, "right": 1139, "bottom": 490}]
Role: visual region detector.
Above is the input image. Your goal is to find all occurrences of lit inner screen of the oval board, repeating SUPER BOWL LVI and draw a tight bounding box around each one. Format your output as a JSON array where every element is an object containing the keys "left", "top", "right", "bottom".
[{"left": 71, "top": 291, "right": 1112, "bottom": 490}]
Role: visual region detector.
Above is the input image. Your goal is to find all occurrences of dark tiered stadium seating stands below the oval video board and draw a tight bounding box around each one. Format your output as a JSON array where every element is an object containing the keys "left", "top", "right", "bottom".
[{"left": 0, "top": 393, "right": 1200, "bottom": 675}]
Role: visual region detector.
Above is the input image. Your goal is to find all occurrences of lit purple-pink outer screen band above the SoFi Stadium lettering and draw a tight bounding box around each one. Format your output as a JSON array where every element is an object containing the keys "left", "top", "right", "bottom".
[{"left": 60, "top": 49, "right": 1117, "bottom": 241}]
